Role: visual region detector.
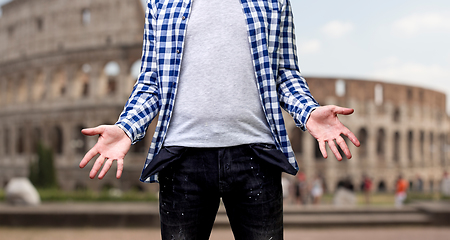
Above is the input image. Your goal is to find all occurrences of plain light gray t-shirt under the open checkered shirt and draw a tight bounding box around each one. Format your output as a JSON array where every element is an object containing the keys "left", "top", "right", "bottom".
[{"left": 164, "top": 0, "right": 273, "bottom": 147}]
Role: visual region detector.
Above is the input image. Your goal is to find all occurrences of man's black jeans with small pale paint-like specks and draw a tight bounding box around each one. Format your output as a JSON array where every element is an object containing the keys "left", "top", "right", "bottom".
[{"left": 159, "top": 145, "right": 283, "bottom": 240}]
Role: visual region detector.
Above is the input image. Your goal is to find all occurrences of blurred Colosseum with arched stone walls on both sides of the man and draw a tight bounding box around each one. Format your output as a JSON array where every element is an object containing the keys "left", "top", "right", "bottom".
[{"left": 0, "top": 0, "right": 450, "bottom": 191}]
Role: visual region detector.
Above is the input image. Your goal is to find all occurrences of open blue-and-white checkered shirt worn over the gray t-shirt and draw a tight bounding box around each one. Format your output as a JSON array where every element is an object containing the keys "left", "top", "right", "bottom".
[{"left": 116, "top": 0, "right": 319, "bottom": 182}]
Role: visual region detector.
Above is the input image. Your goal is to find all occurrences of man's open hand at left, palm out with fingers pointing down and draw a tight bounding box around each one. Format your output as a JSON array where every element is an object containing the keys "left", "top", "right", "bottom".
[{"left": 80, "top": 125, "right": 131, "bottom": 179}]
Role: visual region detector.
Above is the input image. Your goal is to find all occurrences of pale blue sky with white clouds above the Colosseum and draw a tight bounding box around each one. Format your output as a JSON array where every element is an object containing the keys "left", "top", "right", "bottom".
[{"left": 0, "top": 0, "right": 450, "bottom": 112}]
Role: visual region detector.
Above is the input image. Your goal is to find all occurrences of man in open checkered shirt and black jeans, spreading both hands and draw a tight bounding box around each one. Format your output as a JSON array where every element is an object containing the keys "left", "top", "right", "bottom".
[{"left": 80, "top": 0, "right": 359, "bottom": 240}]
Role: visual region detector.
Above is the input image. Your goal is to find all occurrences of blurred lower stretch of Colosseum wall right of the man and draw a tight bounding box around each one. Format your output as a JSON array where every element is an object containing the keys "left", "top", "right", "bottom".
[{"left": 285, "top": 77, "right": 450, "bottom": 192}]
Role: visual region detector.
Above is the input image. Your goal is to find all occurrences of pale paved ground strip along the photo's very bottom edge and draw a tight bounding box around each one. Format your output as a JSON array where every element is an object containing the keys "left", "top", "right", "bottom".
[{"left": 0, "top": 227, "right": 450, "bottom": 240}]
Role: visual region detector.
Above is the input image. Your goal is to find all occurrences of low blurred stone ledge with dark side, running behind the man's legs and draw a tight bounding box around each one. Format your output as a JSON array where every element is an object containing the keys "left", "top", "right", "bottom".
[{"left": 0, "top": 203, "right": 436, "bottom": 228}]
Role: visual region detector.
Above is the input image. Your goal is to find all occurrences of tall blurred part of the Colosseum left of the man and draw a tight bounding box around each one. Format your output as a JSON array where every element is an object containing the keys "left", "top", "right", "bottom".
[{"left": 0, "top": 0, "right": 155, "bottom": 189}]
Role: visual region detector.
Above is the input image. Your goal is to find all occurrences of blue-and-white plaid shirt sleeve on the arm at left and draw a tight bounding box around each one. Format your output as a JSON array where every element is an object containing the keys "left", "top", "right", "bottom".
[{"left": 116, "top": 1, "right": 161, "bottom": 144}]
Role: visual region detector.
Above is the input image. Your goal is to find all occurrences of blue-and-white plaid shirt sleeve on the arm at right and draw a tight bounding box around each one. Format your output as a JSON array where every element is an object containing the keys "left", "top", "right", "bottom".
[{"left": 277, "top": 0, "right": 319, "bottom": 130}]
